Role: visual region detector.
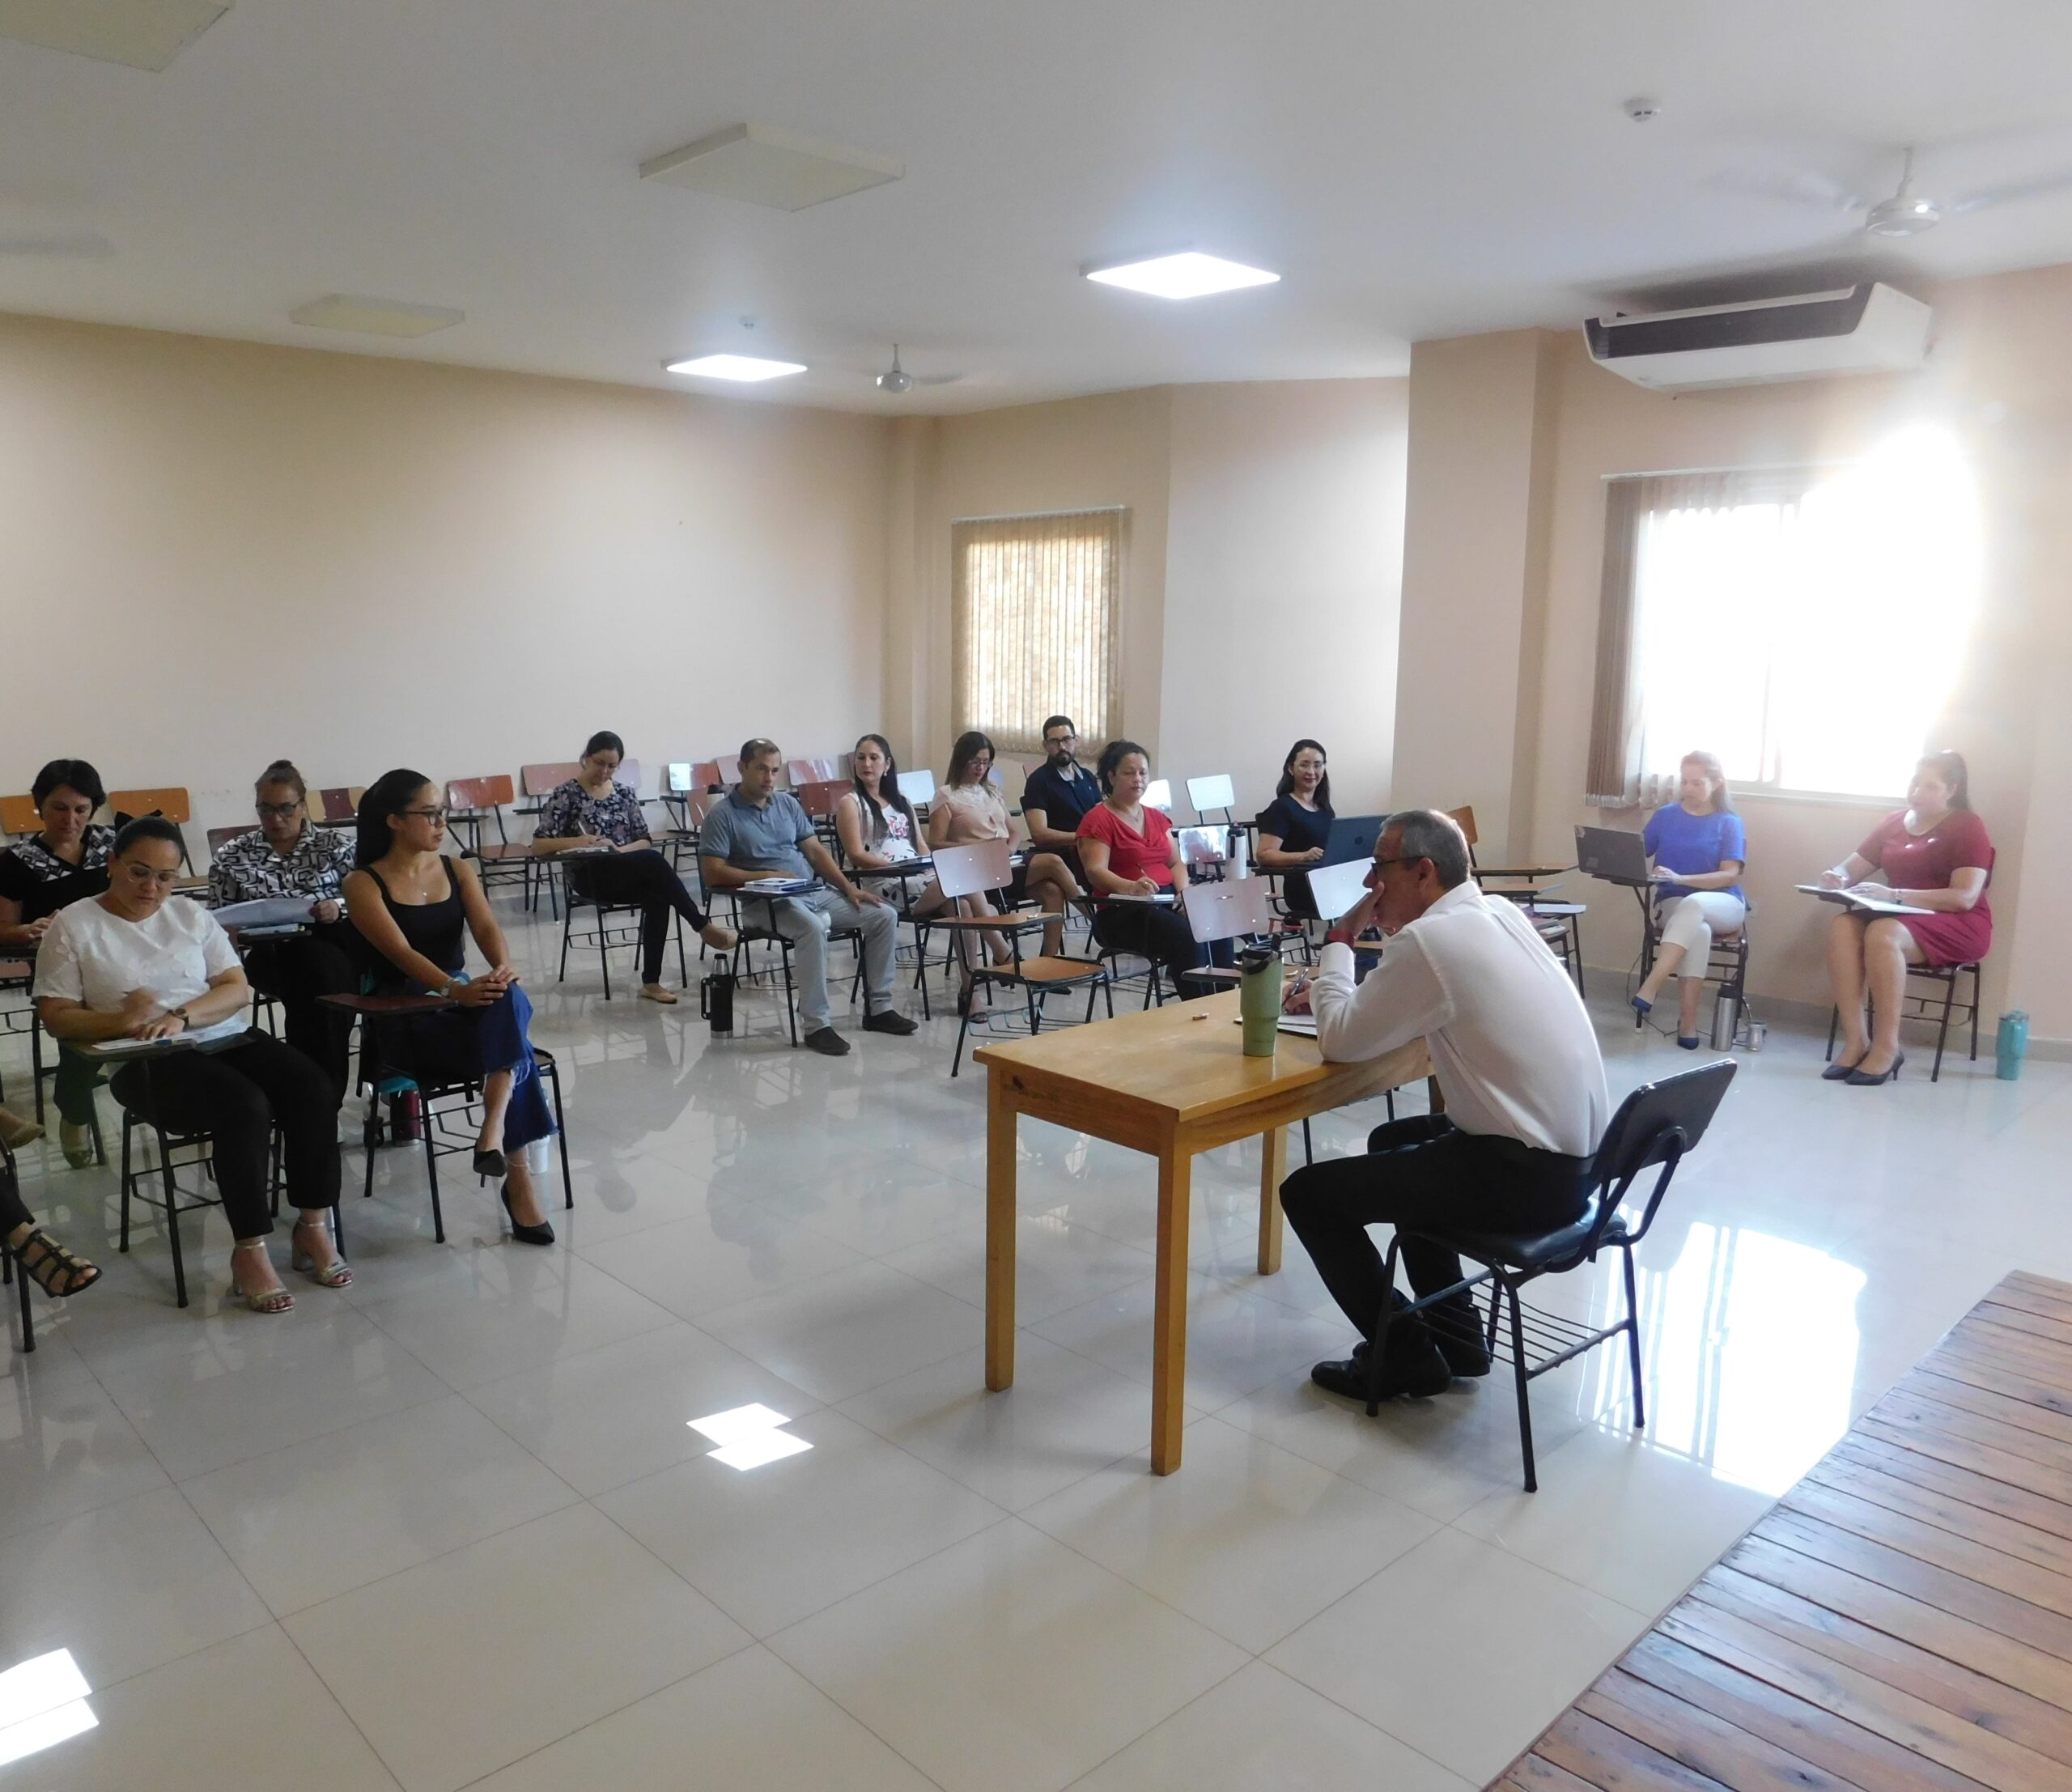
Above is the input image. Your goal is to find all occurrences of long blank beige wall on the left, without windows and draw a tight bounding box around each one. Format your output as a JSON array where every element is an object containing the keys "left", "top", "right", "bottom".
[{"left": 0, "top": 319, "right": 893, "bottom": 845}]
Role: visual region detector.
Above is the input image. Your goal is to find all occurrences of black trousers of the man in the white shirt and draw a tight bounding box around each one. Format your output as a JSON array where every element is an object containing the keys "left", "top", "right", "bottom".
[{"left": 1280, "top": 1115, "right": 1591, "bottom": 1361}]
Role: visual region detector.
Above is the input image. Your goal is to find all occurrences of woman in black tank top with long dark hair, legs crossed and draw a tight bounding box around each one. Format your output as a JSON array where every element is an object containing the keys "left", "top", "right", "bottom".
[{"left": 346, "top": 771, "right": 554, "bottom": 1245}]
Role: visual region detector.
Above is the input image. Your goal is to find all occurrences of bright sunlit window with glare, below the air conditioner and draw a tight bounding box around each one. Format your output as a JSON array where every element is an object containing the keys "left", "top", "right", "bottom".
[{"left": 1590, "top": 429, "right": 1981, "bottom": 806}]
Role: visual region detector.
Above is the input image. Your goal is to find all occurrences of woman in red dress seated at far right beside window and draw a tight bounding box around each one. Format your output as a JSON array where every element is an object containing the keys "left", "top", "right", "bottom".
[{"left": 1819, "top": 752, "right": 1993, "bottom": 1088}]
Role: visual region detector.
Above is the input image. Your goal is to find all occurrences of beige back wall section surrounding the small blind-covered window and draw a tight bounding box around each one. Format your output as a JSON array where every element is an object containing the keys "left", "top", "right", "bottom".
[{"left": 887, "top": 379, "right": 1405, "bottom": 808}]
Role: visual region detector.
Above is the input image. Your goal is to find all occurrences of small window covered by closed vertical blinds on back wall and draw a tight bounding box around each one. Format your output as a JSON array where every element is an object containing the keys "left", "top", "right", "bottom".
[{"left": 949, "top": 510, "right": 1125, "bottom": 752}]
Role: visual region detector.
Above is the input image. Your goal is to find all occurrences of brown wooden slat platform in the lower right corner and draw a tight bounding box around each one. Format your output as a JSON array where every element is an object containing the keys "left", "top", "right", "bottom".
[{"left": 1492, "top": 1274, "right": 2072, "bottom": 1792}]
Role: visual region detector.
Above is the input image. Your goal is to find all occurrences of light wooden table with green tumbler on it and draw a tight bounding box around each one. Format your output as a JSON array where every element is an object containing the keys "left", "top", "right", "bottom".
[{"left": 974, "top": 995, "right": 1432, "bottom": 1475}]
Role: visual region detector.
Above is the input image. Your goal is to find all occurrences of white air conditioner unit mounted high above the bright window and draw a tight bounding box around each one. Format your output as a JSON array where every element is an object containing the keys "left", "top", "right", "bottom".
[{"left": 1583, "top": 280, "right": 1935, "bottom": 392}]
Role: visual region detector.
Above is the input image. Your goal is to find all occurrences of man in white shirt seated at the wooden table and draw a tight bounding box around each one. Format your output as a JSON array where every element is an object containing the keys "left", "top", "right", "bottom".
[{"left": 1280, "top": 810, "right": 1610, "bottom": 1403}]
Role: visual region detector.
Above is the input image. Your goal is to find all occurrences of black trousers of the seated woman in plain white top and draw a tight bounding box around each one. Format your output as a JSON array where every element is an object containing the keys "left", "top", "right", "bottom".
[{"left": 110, "top": 1030, "right": 338, "bottom": 1239}]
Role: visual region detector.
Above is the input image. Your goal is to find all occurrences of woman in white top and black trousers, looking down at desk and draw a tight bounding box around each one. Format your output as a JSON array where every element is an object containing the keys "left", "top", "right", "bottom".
[{"left": 25, "top": 816, "right": 352, "bottom": 1314}]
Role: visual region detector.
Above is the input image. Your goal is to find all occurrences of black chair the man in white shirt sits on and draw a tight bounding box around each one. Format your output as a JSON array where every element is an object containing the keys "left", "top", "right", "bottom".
[{"left": 1368, "top": 1059, "right": 1736, "bottom": 1493}]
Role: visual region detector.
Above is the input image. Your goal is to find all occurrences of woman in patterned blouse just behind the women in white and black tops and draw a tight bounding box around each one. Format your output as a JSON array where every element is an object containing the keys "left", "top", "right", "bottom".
[{"left": 210, "top": 758, "right": 360, "bottom": 1100}]
